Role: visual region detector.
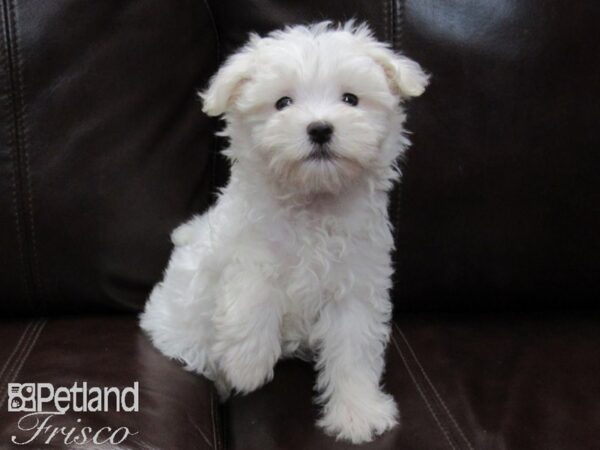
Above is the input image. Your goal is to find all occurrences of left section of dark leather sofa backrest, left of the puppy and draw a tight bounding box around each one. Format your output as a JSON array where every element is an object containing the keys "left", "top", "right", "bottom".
[{"left": 0, "top": 0, "right": 218, "bottom": 315}]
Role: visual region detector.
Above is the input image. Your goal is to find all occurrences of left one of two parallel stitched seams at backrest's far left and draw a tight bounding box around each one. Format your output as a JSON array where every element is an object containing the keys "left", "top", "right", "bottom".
[{"left": 2, "top": 1, "right": 33, "bottom": 304}]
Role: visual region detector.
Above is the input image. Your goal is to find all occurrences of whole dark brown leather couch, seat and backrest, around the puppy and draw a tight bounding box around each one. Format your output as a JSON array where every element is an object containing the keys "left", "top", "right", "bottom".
[{"left": 0, "top": 0, "right": 600, "bottom": 450}]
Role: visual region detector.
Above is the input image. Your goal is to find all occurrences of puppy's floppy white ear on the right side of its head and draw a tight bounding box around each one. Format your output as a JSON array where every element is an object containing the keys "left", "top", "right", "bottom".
[{"left": 371, "top": 46, "right": 429, "bottom": 98}]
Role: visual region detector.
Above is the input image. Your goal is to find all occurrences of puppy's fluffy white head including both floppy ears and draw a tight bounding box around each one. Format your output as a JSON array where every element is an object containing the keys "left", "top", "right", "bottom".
[{"left": 202, "top": 23, "right": 427, "bottom": 193}]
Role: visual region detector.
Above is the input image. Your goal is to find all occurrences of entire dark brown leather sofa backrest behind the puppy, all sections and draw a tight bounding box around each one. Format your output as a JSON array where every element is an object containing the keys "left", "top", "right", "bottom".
[{"left": 0, "top": 0, "right": 600, "bottom": 316}]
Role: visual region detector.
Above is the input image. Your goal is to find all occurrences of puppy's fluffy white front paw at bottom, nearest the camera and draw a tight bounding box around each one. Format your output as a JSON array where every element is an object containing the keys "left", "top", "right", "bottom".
[{"left": 317, "top": 392, "right": 398, "bottom": 444}]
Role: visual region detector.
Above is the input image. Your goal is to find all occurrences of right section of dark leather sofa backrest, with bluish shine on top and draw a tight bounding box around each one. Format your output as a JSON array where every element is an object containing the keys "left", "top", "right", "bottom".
[{"left": 396, "top": 0, "right": 600, "bottom": 309}]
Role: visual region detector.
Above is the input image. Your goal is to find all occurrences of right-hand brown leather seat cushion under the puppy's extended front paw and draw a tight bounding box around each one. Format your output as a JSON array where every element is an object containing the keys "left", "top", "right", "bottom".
[{"left": 226, "top": 315, "right": 600, "bottom": 450}]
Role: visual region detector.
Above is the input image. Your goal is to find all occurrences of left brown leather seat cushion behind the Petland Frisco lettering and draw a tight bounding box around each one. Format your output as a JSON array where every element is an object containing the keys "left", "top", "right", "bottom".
[{"left": 0, "top": 316, "right": 222, "bottom": 450}]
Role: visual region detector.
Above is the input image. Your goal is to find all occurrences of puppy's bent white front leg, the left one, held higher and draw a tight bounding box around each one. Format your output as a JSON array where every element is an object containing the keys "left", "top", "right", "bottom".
[{"left": 212, "top": 262, "right": 282, "bottom": 393}]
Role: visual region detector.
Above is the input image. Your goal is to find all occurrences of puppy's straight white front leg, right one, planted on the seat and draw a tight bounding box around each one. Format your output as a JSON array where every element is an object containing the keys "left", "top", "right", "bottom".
[{"left": 316, "top": 298, "right": 398, "bottom": 444}]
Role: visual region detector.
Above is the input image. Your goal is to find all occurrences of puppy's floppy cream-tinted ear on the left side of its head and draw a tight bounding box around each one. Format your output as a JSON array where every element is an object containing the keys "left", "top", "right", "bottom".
[{"left": 200, "top": 35, "right": 260, "bottom": 116}]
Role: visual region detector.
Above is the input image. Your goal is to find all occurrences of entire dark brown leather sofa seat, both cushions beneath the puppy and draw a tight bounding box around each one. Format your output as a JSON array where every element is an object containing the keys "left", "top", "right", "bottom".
[{"left": 0, "top": 314, "right": 600, "bottom": 450}]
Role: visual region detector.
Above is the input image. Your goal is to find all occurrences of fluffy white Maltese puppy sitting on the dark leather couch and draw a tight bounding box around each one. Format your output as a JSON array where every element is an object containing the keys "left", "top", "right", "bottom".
[{"left": 141, "top": 22, "right": 427, "bottom": 443}]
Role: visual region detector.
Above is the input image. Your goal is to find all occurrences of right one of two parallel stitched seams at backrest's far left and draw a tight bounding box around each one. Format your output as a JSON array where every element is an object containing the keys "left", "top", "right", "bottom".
[{"left": 10, "top": 0, "right": 45, "bottom": 308}]
